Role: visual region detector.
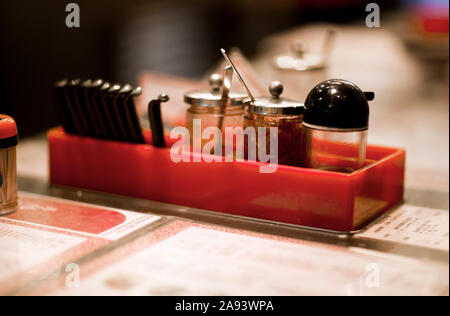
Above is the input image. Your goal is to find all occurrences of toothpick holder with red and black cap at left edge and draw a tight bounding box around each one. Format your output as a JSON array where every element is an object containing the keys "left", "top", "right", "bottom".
[{"left": 0, "top": 114, "right": 17, "bottom": 215}]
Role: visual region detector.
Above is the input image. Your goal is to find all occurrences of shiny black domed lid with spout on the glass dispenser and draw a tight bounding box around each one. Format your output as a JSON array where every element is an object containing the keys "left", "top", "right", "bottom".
[{"left": 303, "top": 79, "right": 375, "bottom": 131}]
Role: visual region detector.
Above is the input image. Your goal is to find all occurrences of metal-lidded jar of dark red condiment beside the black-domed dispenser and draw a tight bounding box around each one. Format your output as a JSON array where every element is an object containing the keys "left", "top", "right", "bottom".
[{"left": 244, "top": 81, "right": 304, "bottom": 166}]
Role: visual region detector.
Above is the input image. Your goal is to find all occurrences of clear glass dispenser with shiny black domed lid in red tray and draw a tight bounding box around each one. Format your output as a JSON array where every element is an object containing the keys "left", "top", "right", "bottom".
[{"left": 302, "top": 79, "right": 374, "bottom": 173}]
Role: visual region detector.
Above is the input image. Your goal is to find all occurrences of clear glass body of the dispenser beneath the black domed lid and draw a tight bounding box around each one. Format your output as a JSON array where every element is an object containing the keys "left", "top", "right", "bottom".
[{"left": 302, "top": 126, "right": 367, "bottom": 173}]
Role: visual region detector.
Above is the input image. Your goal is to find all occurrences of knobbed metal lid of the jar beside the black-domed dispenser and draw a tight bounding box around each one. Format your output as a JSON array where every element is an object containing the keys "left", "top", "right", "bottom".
[{"left": 245, "top": 81, "right": 304, "bottom": 115}]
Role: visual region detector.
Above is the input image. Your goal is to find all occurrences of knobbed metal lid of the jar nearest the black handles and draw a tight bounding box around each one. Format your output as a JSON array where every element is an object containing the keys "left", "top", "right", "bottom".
[{"left": 184, "top": 74, "right": 247, "bottom": 106}]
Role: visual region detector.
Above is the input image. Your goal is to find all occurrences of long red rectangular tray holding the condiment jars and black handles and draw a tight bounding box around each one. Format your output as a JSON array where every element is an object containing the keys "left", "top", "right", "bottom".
[{"left": 48, "top": 128, "right": 405, "bottom": 232}]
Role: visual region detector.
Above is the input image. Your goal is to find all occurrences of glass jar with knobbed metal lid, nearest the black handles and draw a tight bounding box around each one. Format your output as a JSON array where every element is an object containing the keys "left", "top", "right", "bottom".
[{"left": 184, "top": 74, "right": 247, "bottom": 148}]
